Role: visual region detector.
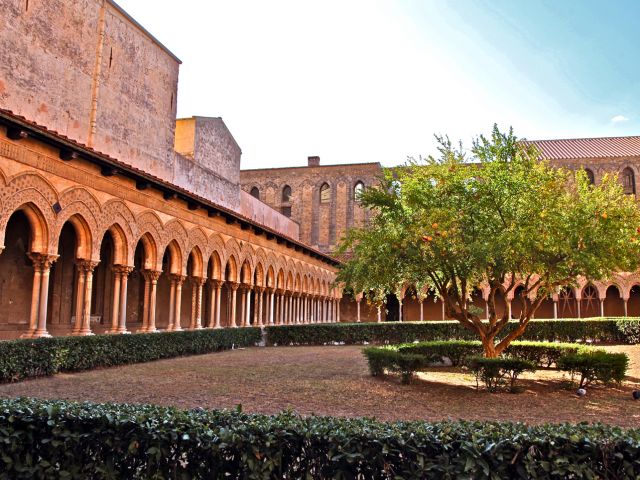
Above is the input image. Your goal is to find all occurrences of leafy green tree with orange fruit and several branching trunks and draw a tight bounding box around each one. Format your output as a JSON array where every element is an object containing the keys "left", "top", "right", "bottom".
[{"left": 337, "top": 126, "right": 640, "bottom": 357}]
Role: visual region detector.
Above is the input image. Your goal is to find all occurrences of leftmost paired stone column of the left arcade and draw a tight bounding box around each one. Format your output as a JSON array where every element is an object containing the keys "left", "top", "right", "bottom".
[{"left": 23, "top": 250, "right": 58, "bottom": 338}]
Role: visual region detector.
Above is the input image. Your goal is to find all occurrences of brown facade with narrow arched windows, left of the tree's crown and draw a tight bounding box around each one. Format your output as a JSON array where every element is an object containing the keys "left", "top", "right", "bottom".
[{"left": 240, "top": 157, "right": 382, "bottom": 252}]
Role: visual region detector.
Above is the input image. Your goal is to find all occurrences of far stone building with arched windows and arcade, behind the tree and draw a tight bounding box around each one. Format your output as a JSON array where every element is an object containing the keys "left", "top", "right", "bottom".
[{"left": 240, "top": 137, "right": 640, "bottom": 321}]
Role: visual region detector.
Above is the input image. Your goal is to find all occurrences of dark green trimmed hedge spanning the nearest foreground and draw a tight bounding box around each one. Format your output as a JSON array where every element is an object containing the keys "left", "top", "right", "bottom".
[{"left": 0, "top": 399, "right": 640, "bottom": 480}]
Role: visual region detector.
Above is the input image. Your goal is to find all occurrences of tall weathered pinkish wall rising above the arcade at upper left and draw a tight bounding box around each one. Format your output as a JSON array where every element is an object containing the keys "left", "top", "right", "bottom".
[{"left": 0, "top": 0, "right": 179, "bottom": 179}]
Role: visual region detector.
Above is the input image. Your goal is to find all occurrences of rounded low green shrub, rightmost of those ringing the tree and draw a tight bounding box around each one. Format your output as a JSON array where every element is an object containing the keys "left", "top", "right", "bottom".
[{"left": 558, "top": 350, "right": 629, "bottom": 387}]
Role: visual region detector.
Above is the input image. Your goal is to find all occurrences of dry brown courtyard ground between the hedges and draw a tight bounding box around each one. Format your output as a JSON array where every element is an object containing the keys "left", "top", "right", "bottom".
[{"left": 0, "top": 345, "right": 640, "bottom": 427}]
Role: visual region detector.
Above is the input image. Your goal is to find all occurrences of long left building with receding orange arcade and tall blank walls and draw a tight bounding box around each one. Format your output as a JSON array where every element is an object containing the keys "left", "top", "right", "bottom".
[{"left": 0, "top": 0, "right": 341, "bottom": 338}]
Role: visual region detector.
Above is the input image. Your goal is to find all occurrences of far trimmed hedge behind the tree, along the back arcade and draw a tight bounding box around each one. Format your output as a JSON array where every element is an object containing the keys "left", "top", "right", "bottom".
[{"left": 266, "top": 318, "right": 627, "bottom": 345}]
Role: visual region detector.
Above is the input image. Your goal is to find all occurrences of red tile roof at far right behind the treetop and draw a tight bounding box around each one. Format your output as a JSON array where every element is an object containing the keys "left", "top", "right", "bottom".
[{"left": 526, "top": 136, "right": 640, "bottom": 160}]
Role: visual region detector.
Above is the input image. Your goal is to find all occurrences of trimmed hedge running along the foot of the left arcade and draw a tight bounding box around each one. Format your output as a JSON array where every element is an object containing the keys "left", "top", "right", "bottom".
[{"left": 0, "top": 328, "right": 262, "bottom": 382}]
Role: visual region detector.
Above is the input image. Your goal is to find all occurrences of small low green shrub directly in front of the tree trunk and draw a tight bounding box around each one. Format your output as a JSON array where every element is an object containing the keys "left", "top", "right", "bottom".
[{"left": 467, "top": 357, "right": 536, "bottom": 393}]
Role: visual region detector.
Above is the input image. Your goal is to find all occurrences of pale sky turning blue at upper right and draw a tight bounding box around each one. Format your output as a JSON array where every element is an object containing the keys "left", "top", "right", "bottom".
[{"left": 117, "top": 0, "right": 640, "bottom": 168}]
